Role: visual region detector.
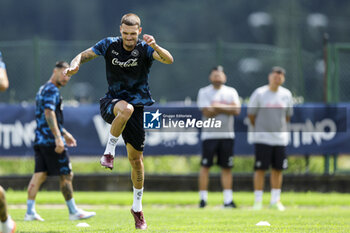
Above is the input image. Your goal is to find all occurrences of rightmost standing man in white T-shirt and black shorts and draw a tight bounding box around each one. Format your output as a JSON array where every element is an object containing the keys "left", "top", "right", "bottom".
[{"left": 248, "top": 66, "right": 293, "bottom": 211}]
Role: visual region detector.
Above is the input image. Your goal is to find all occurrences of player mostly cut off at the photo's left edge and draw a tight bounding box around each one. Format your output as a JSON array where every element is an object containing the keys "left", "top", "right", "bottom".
[{"left": 0, "top": 52, "right": 16, "bottom": 233}]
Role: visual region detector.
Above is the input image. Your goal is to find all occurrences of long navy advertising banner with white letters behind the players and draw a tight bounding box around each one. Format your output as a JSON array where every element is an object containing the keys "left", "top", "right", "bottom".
[{"left": 0, "top": 104, "right": 350, "bottom": 156}]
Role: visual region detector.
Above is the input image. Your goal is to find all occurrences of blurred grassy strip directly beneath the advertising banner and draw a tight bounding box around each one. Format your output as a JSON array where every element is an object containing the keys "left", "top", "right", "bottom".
[{"left": 0, "top": 155, "right": 338, "bottom": 175}]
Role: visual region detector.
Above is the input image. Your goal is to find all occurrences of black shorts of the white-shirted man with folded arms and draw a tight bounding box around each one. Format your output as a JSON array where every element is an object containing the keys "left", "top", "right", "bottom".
[{"left": 201, "top": 139, "right": 235, "bottom": 168}]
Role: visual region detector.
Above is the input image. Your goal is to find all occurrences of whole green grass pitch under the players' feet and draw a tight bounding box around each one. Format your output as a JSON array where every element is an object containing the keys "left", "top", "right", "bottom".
[{"left": 6, "top": 191, "right": 350, "bottom": 233}]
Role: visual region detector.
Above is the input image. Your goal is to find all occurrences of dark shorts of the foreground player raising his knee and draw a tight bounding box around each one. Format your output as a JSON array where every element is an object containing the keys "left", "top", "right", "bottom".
[{"left": 100, "top": 98, "right": 145, "bottom": 151}]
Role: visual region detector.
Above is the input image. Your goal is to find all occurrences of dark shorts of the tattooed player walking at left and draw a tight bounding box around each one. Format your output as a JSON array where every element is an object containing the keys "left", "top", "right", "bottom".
[{"left": 34, "top": 145, "right": 72, "bottom": 176}]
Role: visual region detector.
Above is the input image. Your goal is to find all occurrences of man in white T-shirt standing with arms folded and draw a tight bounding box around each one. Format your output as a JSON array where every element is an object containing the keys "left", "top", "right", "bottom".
[{"left": 197, "top": 66, "right": 241, "bottom": 208}]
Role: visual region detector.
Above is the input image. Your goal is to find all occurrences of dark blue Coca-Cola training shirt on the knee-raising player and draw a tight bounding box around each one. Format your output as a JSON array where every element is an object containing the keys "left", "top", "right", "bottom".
[{"left": 92, "top": 37, "right": 154, "bottom": 105}]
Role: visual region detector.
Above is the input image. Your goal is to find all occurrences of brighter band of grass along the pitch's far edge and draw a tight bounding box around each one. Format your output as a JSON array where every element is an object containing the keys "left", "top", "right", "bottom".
[{"left": 6, "top": 190, "right": 350, "bottom": 206}]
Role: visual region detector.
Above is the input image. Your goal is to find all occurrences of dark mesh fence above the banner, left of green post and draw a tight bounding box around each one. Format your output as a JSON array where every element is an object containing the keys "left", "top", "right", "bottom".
[{"left": 0, "top": 38, "right": 324, "bottom": 102}]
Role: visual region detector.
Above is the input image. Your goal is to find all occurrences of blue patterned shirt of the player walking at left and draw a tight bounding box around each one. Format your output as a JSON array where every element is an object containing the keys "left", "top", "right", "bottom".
[{"left": 34, "top": 82, "right": 64, "bottom": 146}]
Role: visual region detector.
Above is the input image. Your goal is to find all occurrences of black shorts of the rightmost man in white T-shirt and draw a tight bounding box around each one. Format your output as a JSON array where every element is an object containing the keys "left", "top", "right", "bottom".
[{"left": 254, "top": 143, "right": 288, "bottom": 170}]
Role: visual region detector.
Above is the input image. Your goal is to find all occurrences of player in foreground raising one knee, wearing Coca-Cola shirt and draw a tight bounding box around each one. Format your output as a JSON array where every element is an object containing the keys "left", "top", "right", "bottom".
[{"left": 66, "top": 13, "right": 173, "bottom": 229}]
